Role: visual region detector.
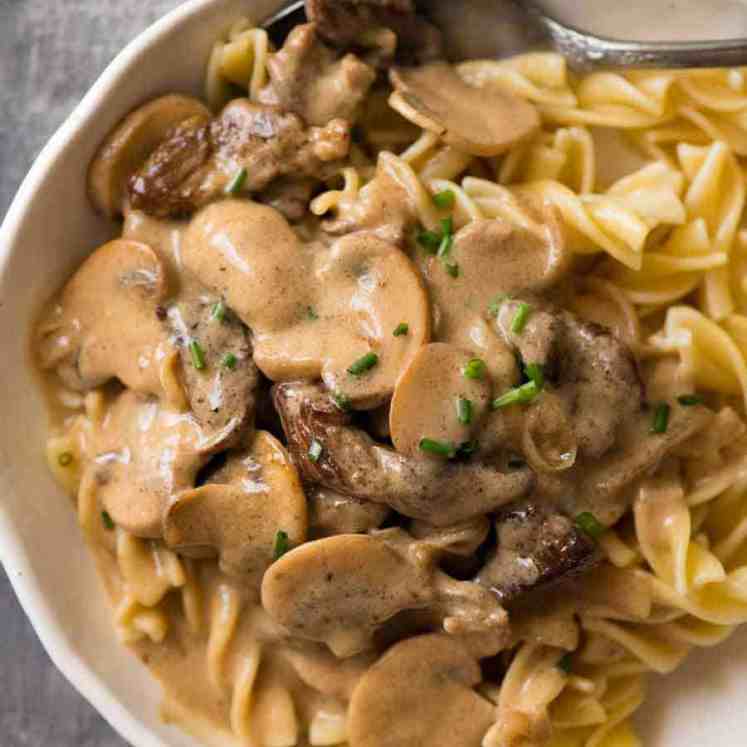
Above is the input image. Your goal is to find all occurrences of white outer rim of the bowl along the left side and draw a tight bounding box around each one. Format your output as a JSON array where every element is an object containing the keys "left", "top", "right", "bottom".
[{"left": 0, "top": 0, "right": 231, "bottom": 747}]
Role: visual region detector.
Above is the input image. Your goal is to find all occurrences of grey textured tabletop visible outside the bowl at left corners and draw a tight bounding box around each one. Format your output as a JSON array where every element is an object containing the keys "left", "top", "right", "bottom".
[{"left": 0, "top": 0, "right": 184, "bottom": 747}]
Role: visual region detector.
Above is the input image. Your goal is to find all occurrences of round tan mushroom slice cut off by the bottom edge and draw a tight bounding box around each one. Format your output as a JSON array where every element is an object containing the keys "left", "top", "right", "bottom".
[{"left": 348, "top": 634, "right": 495, "bottom": 747}]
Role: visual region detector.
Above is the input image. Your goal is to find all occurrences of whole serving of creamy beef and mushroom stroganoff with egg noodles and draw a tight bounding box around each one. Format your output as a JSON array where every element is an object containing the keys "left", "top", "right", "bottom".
[{"left": 34, "top": 0, "right": 747, "bottom": 747}]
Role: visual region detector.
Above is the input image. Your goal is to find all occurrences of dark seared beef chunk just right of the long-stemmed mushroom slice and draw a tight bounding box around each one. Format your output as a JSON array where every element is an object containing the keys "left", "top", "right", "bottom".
[{"left": 477, "top": 502, "right": 601, "bottom": 604}]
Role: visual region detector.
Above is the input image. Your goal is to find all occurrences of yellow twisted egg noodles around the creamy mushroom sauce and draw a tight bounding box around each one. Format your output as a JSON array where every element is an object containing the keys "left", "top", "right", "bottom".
[{"left": 42, "top": 22, "right": 747, "bottom": 747}]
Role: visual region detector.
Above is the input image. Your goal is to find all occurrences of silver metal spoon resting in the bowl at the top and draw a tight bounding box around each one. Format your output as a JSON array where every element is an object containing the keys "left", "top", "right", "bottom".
[{"left": 263, "top": 0, "right": 747, "bottom": 70}]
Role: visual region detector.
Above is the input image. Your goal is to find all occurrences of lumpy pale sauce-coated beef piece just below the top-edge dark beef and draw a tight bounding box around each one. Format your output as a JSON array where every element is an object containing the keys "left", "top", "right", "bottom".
[{"left": 260, "top": 23, "right": 376, "bottom": 125}]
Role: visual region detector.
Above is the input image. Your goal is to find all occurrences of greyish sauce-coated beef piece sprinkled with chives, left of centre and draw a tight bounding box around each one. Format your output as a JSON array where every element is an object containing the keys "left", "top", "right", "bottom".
[{"left": 168, "top": 298, "right": 259, "bottom": 447}]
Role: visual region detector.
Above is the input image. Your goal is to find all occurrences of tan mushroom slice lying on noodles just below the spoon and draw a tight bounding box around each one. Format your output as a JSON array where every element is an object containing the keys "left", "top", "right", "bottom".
[{"left": 389, "top": 62, "right": 540, "bottom": 156}]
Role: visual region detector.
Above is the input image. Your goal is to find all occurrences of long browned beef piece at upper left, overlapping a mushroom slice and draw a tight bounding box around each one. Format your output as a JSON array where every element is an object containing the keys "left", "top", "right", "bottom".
[{"left": 128, "top": 99, "right": 350, "bottom": 217}]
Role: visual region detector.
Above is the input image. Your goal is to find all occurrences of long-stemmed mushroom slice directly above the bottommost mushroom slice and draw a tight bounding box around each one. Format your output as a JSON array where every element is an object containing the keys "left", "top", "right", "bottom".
[{"left": 262, "top": 529, "right": 508, "bottom": 657}]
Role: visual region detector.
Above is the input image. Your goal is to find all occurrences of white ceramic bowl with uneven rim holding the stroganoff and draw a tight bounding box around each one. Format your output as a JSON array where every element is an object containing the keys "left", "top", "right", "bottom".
[{"left": 0, "top": 0, "right": 747, "bottom": 747}]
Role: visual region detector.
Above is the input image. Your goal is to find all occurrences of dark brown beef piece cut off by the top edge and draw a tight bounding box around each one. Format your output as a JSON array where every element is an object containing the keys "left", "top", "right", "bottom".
[{"left": 306, "top": 0, "right": 443, "bottom": 67}]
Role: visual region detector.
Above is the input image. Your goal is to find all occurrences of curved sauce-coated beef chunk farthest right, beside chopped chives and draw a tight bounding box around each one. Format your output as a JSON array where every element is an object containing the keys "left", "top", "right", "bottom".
[{"left": 498, "top": 299, "right": 643, "bottom": 459}]
